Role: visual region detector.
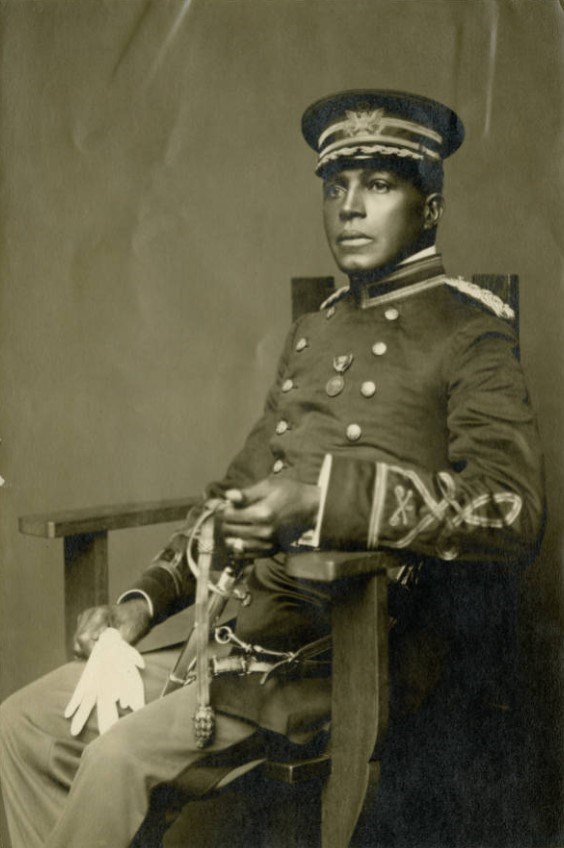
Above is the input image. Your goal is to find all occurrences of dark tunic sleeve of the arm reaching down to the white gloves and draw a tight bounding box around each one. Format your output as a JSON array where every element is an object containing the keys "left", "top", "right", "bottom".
[{"left": 119, "top": 321, "right": 299, "bottom": 624}]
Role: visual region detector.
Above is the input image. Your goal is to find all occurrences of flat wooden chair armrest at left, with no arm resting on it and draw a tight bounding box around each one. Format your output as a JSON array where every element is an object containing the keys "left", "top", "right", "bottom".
[{"left": 18, "top": 497, "right": 199, "bottom": 539}]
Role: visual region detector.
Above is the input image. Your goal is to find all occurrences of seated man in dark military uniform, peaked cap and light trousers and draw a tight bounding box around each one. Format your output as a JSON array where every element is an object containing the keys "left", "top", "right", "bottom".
[{"left": 2, "top": 91, "right": 543, "bottom": 848}]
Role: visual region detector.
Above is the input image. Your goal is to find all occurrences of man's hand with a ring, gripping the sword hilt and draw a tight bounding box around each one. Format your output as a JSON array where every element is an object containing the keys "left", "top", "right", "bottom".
[{"left": 218, "top": 477, "right": 320, "bottom": 556}]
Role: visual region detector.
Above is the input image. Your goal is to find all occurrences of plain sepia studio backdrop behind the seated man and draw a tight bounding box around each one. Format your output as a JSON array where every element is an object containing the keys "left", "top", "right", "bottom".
[{"left": 0, "top": 0, "right": 564, "bottom": 848}]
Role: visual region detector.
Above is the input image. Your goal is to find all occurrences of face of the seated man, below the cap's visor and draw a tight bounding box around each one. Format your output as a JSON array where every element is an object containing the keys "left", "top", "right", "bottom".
[{"left": 323, "top": 168, "right": 426, "bottom": 276}]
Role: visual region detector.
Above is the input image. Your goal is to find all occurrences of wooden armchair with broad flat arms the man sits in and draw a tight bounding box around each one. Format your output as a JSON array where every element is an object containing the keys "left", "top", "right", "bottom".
[{"left": 19, "top": 275, "right": 518, "bottom": 848}]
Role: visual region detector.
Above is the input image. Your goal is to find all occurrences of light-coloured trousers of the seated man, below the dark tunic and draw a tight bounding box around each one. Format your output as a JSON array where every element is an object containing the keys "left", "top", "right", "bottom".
[{"left": 0, "top": 650, "right": 265, "bottom": 848}]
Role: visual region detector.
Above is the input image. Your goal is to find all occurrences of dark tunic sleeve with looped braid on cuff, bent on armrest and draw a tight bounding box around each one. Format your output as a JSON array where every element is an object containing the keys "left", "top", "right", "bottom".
[{"left": 320, "top": 316, "right": 544, "bottom": 564}]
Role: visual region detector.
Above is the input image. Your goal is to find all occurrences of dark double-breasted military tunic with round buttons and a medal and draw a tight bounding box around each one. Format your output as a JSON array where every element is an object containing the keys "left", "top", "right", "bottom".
[{"left": 126, "top": 256, "right": 543, "bottom": 738}]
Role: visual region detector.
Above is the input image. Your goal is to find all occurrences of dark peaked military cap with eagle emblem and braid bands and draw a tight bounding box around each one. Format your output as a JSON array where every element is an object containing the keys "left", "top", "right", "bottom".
[{"left": 302, "top": 89, "right": 464, "bottom": 174}]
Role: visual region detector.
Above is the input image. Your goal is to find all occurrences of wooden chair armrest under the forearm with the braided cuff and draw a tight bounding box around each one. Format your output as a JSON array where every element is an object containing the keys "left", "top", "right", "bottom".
[{"left": 286, "top": 551, "right": 392, "bottom": 583}]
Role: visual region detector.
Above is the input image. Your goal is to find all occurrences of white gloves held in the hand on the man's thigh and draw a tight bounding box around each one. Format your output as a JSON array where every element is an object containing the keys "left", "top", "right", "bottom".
[{"left": 64, "top": 627, "right": 145, "bottom": 736}]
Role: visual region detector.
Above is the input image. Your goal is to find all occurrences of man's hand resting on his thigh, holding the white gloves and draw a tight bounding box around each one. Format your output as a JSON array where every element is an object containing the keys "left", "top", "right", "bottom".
[{"left": 73, "top": 598, "right": 151, "bottom": 659}]
